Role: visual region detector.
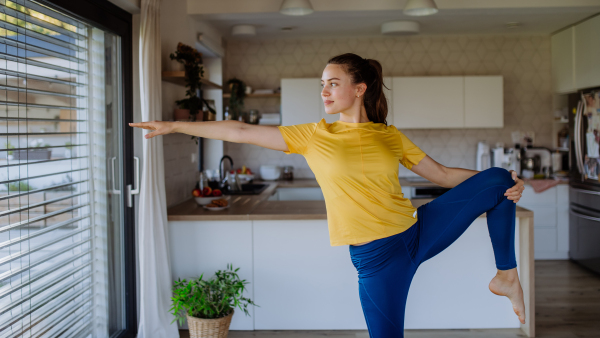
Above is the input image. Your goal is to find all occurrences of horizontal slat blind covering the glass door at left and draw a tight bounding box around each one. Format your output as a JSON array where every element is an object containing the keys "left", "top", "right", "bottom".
[{"left": 0, "top": 0, "right": 95, "bottom": 338}]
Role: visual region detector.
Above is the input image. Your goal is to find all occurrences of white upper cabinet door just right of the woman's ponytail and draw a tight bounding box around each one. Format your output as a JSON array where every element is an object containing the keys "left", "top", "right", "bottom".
[{"left": 392, "top": 76, "right": 464, "bottom": 129}]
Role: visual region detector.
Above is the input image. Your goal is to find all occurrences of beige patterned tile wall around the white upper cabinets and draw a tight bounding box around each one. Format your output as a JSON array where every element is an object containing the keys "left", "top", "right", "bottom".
[{"left": 224, "top": 35, "right": 553, "bottom": 180}]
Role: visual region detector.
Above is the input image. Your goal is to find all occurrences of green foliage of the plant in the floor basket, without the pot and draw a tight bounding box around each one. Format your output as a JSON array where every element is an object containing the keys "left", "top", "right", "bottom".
[{"left": 170, "top": 264, "right": 258, "bottom": 324}]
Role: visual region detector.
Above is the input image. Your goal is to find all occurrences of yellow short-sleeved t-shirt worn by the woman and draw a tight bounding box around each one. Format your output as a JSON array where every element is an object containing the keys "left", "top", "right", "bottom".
[{"left": 279, "top": 119, "right": 426, "bottom": 246}]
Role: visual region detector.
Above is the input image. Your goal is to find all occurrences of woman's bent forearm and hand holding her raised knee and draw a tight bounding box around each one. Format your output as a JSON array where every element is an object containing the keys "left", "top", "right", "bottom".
[{"left": 410, "top": 155, "right": 525, "bottom": 203}]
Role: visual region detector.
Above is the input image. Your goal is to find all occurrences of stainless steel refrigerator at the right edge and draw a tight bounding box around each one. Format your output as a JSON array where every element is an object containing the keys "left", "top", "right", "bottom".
[{"left": 568, "top": 88, "right": 600, "bottom": 274}]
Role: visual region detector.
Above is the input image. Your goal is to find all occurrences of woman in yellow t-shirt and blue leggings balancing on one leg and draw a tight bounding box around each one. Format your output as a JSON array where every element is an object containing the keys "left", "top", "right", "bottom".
[{"left": 131, "top": 53, "right": 525, "bottom": 338}]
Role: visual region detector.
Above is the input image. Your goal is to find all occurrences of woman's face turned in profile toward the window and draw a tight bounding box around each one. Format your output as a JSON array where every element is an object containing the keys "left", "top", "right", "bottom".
[{"left": 321, "top": 64, "right": 367, "bottom": 114}]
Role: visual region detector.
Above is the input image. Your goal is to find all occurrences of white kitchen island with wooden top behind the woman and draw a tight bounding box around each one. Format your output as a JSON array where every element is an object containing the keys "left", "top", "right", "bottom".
[{"left": 167, "top": 179, "right": 535, "bottom": 337}]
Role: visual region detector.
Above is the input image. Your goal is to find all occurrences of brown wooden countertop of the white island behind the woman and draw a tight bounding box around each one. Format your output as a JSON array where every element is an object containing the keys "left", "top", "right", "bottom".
[{"left": 167, "top": 179, "right": 533, "bottom": 221}]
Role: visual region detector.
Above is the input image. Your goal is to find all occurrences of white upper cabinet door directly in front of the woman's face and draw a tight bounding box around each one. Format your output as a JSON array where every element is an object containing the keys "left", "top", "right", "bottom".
[{"left": 281, "top": 78, "right": 323, "bottom": 126}]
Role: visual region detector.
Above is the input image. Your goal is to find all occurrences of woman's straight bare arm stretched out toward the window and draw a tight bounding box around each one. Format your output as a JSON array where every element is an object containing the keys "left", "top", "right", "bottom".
[{"left": 129, "top": 120, "right": 289, "bottom": 151}]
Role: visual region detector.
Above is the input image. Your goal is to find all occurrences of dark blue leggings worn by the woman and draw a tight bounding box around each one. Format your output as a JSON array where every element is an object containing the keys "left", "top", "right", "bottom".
[{"left": 350, "top": 168, "right": 517, "bottom": 338}]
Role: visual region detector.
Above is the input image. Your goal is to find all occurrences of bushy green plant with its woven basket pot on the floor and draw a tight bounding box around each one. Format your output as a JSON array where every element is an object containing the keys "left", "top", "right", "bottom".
[{"left": 170, "top": 264, "right": 257, "bottom": 338}]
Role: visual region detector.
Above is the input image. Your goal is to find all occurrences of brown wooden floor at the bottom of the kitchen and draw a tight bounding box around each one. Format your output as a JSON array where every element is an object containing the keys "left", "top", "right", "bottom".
[{"left": 180, "top": 260, "right": 600, "bottom": 338}]
